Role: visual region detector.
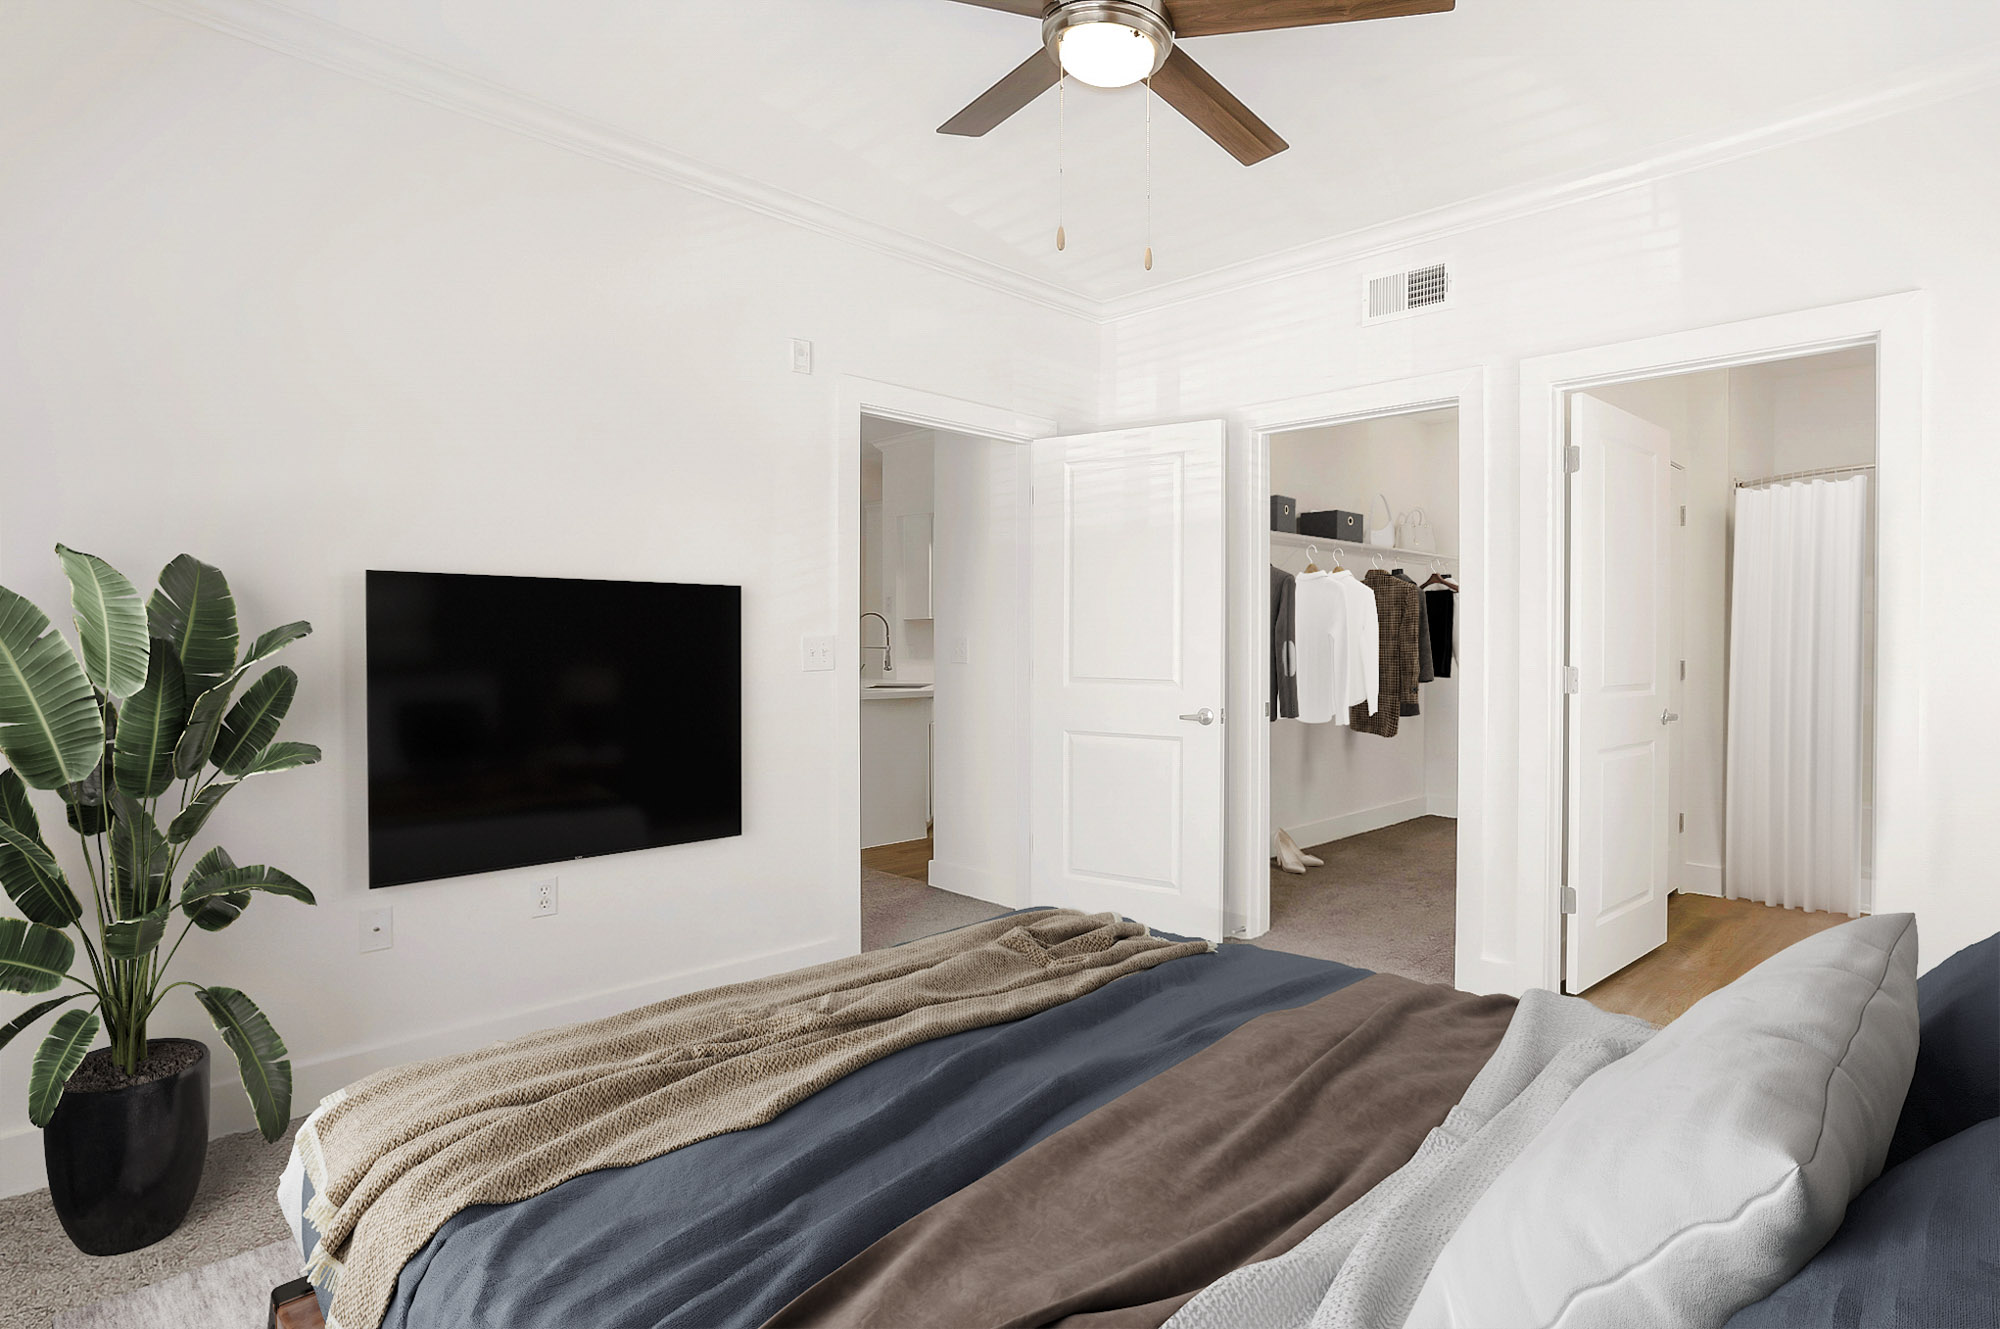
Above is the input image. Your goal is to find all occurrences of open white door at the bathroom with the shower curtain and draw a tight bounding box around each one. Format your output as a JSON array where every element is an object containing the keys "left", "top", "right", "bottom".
[{"left": 1564, "top": 392, "right": 1680, "bottom": 993}]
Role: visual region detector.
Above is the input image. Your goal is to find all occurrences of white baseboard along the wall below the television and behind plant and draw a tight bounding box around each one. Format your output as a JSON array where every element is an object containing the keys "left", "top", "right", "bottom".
[{"left": 0, "top": 937, "right": 854, "bottom": 1197}]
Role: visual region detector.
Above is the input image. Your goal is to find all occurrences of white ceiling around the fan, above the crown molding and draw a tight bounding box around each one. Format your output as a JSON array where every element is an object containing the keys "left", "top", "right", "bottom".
[{"left": 238, "top": 0, "right": 2000, "bottom": 300}]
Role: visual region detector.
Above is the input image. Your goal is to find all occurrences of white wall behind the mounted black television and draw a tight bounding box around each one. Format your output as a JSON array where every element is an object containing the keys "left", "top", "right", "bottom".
[{"left": 0, "top": 0, "right": 1098, "bottom": 1193}]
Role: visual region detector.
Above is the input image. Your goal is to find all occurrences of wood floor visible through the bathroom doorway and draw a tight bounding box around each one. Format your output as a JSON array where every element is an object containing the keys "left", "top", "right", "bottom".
[{"left": 1584, "top": 895, "right": 1848, "bottom": 1025}]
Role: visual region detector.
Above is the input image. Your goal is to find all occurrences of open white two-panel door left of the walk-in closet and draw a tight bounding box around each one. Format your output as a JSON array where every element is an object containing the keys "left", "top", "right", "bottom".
[{"left": 1032, "top": 420, "right": 1226, "bottom": 939}]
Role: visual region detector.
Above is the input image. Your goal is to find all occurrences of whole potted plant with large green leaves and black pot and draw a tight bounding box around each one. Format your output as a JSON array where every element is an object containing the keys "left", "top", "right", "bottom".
[{"left": 0, "top": 544, "right": 320, "bottom": 1255}]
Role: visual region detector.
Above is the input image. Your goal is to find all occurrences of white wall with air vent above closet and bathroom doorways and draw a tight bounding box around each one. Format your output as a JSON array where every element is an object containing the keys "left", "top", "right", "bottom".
[{"left": 1104, "top": 84, "right": 2000, "bottom": 973}]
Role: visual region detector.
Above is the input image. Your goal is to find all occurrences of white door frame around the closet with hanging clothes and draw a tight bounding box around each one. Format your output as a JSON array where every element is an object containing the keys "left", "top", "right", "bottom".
[{"left": 1224, "top": 368, "right": 1512, "bottom": 991}]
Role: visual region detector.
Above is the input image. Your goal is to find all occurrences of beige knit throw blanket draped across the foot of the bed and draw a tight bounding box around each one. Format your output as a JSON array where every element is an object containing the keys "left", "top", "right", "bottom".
[{"left": 298, "top": 909, "right": 1212, "bottom": 1329}]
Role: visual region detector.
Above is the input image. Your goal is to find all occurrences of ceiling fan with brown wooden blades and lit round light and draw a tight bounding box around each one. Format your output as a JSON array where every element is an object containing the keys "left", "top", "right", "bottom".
[{"left": 938, "top": 0, "right": 1456, "bottom": 166}]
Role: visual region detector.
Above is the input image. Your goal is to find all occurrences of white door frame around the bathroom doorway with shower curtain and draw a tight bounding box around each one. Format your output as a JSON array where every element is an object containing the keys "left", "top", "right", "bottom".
[{"left": 1520, "top": 292, "right": 1928, "bottom": 989}]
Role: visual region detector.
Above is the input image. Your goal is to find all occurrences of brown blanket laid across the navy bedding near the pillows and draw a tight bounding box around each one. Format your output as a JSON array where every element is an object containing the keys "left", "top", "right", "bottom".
[{"left": 766, "top": 975, "right": 1514, "bottom": 1329}]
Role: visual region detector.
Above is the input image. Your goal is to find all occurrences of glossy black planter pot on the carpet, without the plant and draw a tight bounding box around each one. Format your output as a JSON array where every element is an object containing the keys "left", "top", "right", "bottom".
[{"left": 42, "top": 1039, "right": 208, "bottom": 1255}]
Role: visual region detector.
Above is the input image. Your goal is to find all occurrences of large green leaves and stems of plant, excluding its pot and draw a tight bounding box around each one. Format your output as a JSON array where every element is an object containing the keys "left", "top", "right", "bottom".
[{"left": 0, "top": 544, "right": 320, "bottom": 1139}]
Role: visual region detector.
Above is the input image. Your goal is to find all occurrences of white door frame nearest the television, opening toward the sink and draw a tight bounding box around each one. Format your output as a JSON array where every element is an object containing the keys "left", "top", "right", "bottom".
[{"left": 828, "top": 374, "right": 1062, "bottom": 951}]
